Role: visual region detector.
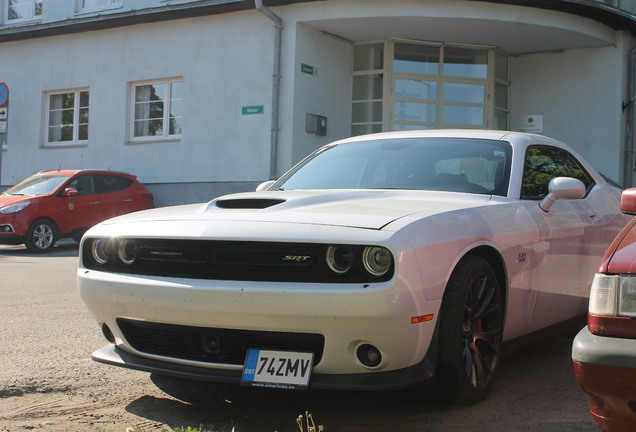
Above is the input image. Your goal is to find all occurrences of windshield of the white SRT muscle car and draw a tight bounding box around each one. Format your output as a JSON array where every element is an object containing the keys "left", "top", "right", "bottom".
[{"left": 271, "top": 138, "right": 512, "bottom": 196}]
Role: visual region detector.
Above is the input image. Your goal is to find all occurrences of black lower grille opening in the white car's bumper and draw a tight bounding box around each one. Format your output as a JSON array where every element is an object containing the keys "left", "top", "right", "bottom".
[{"left": 117, "top": 318, "right": 325, "bottom": 365}]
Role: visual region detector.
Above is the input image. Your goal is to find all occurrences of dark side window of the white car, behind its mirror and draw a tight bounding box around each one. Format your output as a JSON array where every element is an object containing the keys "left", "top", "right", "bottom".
[{"left": 521, "top": 146, "right": 594, "bottom": 200}]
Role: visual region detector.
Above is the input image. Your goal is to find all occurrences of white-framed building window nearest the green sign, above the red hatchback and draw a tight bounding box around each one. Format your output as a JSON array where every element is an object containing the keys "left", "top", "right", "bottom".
[{"left": 131, "top": 79, "right": 183, "bottom": 141}]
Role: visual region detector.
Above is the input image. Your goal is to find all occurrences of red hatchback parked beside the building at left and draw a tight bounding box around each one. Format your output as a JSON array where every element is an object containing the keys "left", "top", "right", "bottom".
[{"left": 0, "top": 170, "right": 153, "bottom": 252}]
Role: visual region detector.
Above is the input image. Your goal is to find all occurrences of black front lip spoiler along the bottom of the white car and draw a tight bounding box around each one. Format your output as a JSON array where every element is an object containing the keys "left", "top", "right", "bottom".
[{"left": 91, "top": 344, "right": 433, "bottom": 391}]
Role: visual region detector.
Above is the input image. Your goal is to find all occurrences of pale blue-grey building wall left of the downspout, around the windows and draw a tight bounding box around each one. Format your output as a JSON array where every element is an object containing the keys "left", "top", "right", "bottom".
[{"left": 0, "top": 11, "right": 273, "bottom": 184}]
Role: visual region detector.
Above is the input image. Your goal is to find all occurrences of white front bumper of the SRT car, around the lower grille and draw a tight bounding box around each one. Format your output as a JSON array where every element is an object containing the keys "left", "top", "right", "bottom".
[{"left": 78, "top": 260, "right": 441, "bottom": 382}]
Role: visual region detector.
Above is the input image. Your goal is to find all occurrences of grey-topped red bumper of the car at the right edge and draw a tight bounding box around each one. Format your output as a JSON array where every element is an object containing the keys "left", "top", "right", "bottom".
[{"left": 572, "top": 327, "right": 636, "bottom": 432}]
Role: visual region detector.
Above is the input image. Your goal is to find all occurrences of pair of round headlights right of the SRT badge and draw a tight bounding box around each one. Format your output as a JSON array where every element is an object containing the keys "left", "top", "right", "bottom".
[{"left": 326, "top": 245, "right": 393, "bottom": 277}]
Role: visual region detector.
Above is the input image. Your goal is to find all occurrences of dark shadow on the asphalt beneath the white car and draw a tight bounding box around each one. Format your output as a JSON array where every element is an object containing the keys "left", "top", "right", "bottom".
[{"left": 126, "top": 326, "right": 598, "bottom": 432}]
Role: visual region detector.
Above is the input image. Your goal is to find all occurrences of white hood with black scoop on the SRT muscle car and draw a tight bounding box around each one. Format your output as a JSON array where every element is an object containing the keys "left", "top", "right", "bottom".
[{"left": 106, "top": 190, "right": 492, "bottom": 229}]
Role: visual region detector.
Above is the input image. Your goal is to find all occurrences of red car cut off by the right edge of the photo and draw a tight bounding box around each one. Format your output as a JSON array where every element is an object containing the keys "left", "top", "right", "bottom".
[{"left": 572, "top": 188, "right": 636, "bottom": 432}]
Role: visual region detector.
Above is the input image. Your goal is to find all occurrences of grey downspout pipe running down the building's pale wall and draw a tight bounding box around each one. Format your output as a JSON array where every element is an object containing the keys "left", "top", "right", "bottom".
[{"left": 255, "top": 0, "right": 283, "bottom": 179}]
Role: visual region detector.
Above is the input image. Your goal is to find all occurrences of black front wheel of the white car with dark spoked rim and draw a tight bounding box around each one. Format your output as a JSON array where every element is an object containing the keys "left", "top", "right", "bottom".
[{"left": 433, "top": 256, "right": 503, "bottom": 404}]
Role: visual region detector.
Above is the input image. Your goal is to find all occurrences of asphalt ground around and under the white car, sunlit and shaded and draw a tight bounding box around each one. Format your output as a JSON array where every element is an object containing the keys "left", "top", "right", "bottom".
[{"left": 0, "top": 243, "right": 599, "bottom": 432}]
